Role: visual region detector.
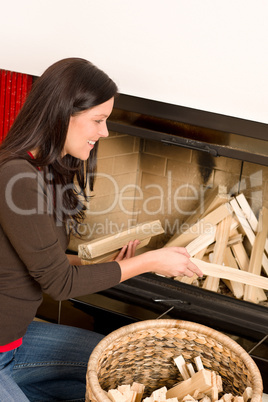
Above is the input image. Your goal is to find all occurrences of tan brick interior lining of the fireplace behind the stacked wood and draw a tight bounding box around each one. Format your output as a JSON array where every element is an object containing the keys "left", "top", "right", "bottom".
[{"left": 70, "top": 132, "right": 268, "bottom": 250}]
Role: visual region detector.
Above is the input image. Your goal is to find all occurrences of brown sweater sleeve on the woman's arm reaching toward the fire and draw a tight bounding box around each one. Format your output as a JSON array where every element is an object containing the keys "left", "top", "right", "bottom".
[{"left": 0, "top": 161, "right": 121, "bottom": 300}]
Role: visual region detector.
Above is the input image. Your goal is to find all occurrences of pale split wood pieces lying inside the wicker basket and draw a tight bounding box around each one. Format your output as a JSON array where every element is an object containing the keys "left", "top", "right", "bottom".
[{"left": 107, "top": 355, "right": 252, "bottom": 402}]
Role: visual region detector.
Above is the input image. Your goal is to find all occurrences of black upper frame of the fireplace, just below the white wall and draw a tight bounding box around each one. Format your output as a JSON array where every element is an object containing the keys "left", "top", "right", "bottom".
[{"left": 108, "top": 94, "right": 268, "bottom": 166}]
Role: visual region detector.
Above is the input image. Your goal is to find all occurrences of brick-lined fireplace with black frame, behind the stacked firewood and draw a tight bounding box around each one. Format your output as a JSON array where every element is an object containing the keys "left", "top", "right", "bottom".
[{"left": 67, "top": 95, "right": 268, "bottom": 391}]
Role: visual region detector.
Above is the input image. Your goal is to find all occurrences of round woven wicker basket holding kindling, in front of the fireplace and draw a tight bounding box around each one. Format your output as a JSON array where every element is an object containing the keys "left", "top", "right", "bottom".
[{"left": 86, "top": 319, "right": 263, "bottom": 402}]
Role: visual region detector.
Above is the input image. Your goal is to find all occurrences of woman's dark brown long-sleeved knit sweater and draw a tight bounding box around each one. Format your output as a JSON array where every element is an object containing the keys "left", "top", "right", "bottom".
[{"left": 0, "top": 160, "right": 121, "bottom": 345}]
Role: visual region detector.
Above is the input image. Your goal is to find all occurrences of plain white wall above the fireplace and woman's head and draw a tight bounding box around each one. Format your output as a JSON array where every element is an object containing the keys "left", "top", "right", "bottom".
[{"left": 0, "top": 0, "right": 268, "bottom": 124}]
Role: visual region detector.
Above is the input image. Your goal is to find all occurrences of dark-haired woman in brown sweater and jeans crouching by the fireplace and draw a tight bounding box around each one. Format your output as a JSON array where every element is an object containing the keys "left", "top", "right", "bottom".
[{"left": 0, "top": 58, "right": 202, "bottom": 402}]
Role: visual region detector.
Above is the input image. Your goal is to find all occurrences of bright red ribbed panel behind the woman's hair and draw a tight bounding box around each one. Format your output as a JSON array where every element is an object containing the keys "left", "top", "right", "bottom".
[{"left": 0, "top": 69, "right": 33, "bottom": 143}]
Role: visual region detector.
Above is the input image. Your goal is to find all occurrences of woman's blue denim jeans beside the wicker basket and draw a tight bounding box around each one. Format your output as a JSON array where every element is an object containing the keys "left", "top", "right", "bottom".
[{"left": 0, "top": 321, "right": 103, "bottom": 402}]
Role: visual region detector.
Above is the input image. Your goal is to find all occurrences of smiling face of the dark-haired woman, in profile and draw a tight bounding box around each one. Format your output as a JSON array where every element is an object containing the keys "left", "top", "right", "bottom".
[{"left": 62, "top": 98, "right": 114, "bottom": 160}]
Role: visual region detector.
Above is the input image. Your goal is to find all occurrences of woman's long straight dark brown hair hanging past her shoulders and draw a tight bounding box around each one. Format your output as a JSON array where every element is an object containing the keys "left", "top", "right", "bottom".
[{"left": 0, "top": 58, "right": 117, "bottom": 223}]
